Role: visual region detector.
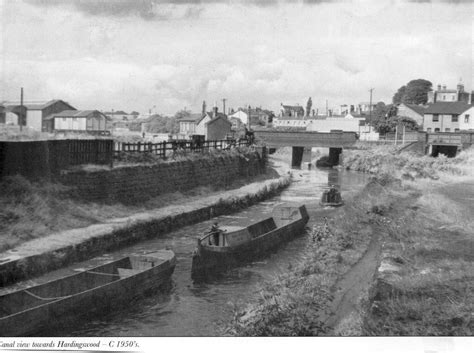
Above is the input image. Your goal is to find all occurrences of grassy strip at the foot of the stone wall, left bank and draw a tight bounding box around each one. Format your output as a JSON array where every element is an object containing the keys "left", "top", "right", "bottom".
[{"left": 0, "top": 151, "right": 278, "bottom": 252}]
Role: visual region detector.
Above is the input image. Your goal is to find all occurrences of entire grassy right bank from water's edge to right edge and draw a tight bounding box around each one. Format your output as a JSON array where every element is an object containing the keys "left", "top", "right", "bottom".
[{"left": 225, "top": 146, "right": 474, "bottom": 336}]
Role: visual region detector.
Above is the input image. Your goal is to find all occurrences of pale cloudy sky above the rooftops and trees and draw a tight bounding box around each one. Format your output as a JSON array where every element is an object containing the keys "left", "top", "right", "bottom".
[{"left": 0, "top": 0, "right": 474, "bottom": 115}]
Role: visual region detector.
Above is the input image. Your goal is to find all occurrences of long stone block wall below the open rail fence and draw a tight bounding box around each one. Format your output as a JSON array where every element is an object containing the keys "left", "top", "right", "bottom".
[{"left": 59, "top": 150, "right": 266, "bottom": 204}]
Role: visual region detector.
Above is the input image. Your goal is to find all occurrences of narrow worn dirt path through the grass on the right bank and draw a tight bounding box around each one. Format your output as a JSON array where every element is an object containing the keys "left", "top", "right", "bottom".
[{"left": 325, "top": 234, "right": 382, "bottom": 336}]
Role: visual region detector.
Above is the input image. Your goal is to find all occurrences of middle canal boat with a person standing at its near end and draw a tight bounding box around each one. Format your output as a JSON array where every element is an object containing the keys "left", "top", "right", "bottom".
[{"left": 191, "top": 205, "right": 309, "bottom": 279}]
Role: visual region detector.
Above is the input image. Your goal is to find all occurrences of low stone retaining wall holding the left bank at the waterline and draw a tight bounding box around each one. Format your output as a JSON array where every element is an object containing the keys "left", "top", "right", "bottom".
[{"left": 0, "top": 177, "right": 291, "bottom": 287}]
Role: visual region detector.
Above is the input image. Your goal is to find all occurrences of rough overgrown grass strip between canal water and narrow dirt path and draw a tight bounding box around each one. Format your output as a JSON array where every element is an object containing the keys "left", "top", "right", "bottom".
[{"left": 224, "top": 175, "right": 400, "bottom": 336}]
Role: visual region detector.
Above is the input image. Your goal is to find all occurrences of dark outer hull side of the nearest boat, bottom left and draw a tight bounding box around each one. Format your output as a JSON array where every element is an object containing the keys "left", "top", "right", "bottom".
[{"left": 0, "top": 249, "right": 176, "bottom": 336}]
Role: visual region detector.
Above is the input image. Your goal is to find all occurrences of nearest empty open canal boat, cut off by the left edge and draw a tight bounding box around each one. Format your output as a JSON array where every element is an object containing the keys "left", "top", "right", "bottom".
[{"left": 0, "top": 250, "right": 176, "bottom": 336}]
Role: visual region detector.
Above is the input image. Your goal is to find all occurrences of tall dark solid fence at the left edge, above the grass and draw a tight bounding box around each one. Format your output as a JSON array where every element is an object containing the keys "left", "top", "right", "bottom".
[{"left": 0, "top": 140, "right": 113, "bottom": 178}]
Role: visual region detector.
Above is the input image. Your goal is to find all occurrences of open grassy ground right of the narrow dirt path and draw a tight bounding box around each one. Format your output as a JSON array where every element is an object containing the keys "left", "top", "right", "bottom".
[{"left": 344, "top": 148, "right": 474, "bottom": 336}]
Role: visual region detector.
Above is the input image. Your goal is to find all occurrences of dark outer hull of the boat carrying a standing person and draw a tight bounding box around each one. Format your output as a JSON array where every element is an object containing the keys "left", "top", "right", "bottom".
[{"left": 191, "top": 206, "right": 309, "bottom": 279}]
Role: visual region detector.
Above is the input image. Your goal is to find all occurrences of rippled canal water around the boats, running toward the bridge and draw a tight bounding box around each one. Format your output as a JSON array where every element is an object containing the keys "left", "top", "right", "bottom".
[{"left": 39, "top": 165, "right": 367, "bottom": 336}]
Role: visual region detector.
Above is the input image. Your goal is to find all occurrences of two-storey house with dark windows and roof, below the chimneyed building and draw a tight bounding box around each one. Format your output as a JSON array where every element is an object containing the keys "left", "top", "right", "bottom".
[{"left": 423, "top": 102, "right": 472, "bottom": 132}]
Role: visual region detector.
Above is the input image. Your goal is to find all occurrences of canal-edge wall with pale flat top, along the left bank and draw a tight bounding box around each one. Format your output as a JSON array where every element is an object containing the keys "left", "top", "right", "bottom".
[{"left": 0, "top": 175, "right": 291, "bottom": 286}]
